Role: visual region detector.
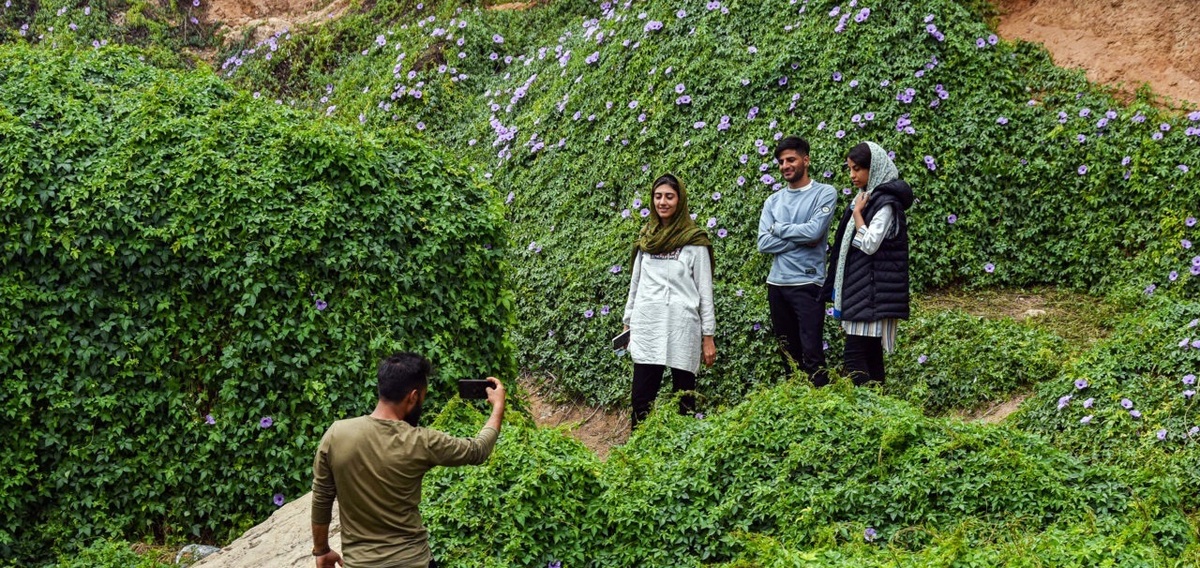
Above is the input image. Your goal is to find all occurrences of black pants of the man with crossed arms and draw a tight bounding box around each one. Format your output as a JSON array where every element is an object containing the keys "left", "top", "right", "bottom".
[{"left": 767, "top": 285, "right": 829, "bottom": 387}]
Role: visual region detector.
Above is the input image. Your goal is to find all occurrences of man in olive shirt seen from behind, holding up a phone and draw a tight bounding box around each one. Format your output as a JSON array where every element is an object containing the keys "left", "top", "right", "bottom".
[{"left": 312, "top": 353, "right": 504, "bottom": 568}]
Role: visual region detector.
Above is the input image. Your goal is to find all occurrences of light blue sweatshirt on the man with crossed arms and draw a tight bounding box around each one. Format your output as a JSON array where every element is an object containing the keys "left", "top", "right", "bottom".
[{"left": 758, "top": 181, "right": 838, "bottom": 286}]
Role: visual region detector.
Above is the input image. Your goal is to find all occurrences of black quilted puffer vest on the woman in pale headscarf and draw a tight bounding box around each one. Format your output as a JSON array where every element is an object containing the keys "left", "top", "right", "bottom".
[{"left": 824, "top": 180, "right": 912, "bottom": 322}]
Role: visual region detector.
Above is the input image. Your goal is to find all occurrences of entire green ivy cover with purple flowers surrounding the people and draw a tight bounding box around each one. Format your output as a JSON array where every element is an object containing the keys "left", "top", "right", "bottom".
[{"left": 0, "top": 0, "right": 1200, "bottom": 567}]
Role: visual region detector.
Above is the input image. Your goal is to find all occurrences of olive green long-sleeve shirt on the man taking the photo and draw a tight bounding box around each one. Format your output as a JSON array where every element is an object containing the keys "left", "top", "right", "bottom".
[{"left": 312, "top": 415, "right": 499, "bottom": 568}]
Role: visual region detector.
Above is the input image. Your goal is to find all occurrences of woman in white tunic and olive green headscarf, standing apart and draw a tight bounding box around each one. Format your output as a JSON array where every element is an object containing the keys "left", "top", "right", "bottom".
[{"left": 623, "top": 174, "right": 716, "bottom": 428}]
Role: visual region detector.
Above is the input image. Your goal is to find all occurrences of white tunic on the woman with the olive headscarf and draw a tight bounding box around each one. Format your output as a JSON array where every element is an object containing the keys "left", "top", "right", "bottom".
[{"left": 623, "top": 245, "right": 716, "bottom": 373}]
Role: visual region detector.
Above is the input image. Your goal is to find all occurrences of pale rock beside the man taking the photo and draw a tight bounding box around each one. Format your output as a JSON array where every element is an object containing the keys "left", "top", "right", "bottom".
[{"left": 192, "top": 492, "right": 342, "bottom": 568}]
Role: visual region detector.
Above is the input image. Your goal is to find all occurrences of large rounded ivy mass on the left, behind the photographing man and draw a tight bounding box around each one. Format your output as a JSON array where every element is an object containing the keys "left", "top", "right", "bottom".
[{"left": 0, "top": 47, "right": 514, "bottom": 558}]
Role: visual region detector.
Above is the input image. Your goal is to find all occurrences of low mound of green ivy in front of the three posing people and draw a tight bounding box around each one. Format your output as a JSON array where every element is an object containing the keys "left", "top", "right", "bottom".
[{"left": 321, "top": 381, "right": 1200, "bottom": 567}]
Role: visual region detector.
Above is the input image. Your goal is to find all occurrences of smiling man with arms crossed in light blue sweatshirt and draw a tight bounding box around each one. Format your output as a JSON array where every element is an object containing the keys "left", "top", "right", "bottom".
[{"left": 758, "top": 136, "right": 838, "bottom": 387}]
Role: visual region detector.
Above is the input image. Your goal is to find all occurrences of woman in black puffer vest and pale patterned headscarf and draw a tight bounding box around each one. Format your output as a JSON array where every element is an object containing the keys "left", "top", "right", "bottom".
[{"left": 824, "top": 142, "right": 912, "bottom": 385}]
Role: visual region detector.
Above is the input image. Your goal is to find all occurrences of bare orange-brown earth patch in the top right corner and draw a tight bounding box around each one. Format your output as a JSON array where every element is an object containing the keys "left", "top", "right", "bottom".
[{"left": 995, "top": 0, "right": 1200, "bottom": 107}]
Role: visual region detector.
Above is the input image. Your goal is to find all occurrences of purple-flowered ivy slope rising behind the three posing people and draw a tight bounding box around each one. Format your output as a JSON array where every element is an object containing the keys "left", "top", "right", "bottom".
[{"left": 206, "top": 0, "right": 1200, "bottom": 402}]
